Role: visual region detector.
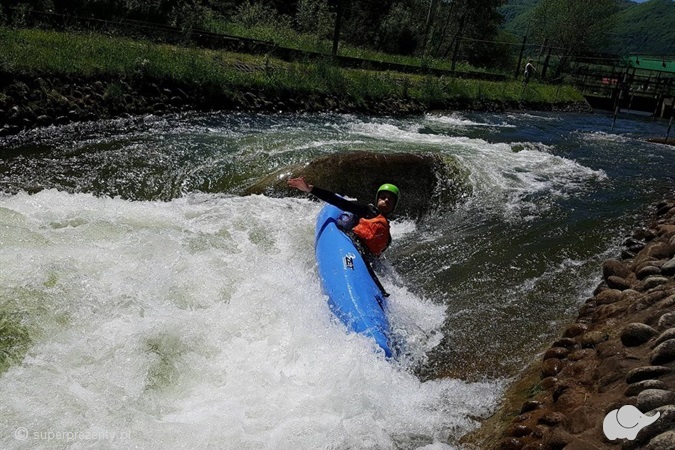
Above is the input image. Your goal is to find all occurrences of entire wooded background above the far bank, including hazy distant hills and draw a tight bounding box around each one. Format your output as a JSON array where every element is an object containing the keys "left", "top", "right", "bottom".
[{"left": 0, "top": 0, "right": 675, "bottom": 73}]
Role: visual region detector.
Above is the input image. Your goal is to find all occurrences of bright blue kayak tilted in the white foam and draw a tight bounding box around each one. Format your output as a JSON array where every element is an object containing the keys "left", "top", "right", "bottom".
[{"left": 314, "top": 205, "right": 392, "bottom": 357}]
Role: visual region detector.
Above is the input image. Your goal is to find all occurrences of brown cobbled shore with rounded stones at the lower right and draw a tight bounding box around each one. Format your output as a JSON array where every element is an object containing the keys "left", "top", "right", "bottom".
[{"left": 464, "top": 200, "right": 675, "bottom": 450}]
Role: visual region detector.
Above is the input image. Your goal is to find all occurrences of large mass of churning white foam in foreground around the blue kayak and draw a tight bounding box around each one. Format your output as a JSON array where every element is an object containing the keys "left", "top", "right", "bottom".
[{"left": 0, "top": 191, "right": 501, "bottom": 449}]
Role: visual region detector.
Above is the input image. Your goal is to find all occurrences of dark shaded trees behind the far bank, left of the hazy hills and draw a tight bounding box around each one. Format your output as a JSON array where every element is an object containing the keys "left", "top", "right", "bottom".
[{"left": 0, "top": 0, "right": 503, "bottom": 66}]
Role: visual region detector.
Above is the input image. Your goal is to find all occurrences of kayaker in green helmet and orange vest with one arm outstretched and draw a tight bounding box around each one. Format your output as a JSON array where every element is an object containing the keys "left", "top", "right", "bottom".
[{"left": 288, "top": 177, "right": 400, "bottom": 257}]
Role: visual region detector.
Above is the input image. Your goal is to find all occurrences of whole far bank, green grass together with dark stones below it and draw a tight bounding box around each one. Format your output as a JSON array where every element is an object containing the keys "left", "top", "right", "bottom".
[{"left": 0, "top": 27, "right": 587, "bottom": 136}]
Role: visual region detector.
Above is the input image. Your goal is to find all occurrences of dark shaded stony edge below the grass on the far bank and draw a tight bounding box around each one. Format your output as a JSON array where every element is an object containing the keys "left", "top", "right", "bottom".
[{"left": 0, "top": 70, "right": 591, "bottom": 137}]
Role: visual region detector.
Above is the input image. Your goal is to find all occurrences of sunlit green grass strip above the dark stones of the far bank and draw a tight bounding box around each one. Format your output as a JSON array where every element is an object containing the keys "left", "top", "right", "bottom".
[{"left": 0, "top": 27, "right": 582, "bottom": 109}]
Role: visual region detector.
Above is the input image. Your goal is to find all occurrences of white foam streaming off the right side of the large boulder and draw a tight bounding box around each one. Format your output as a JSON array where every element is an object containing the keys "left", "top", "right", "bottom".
[{"left": 349, "top": 115, "right": 607, "bottom": 221}]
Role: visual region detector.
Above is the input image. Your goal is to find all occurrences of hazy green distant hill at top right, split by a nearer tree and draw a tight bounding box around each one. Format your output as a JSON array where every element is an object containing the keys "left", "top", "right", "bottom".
[{"left": 500, "top": 0, "right": 675, "bottom": 56}]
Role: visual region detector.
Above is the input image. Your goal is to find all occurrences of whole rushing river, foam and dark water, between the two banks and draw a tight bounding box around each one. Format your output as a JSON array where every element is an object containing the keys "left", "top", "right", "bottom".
[{"left": 0, "top": 113, "right": 675, "bottom": 449}]
